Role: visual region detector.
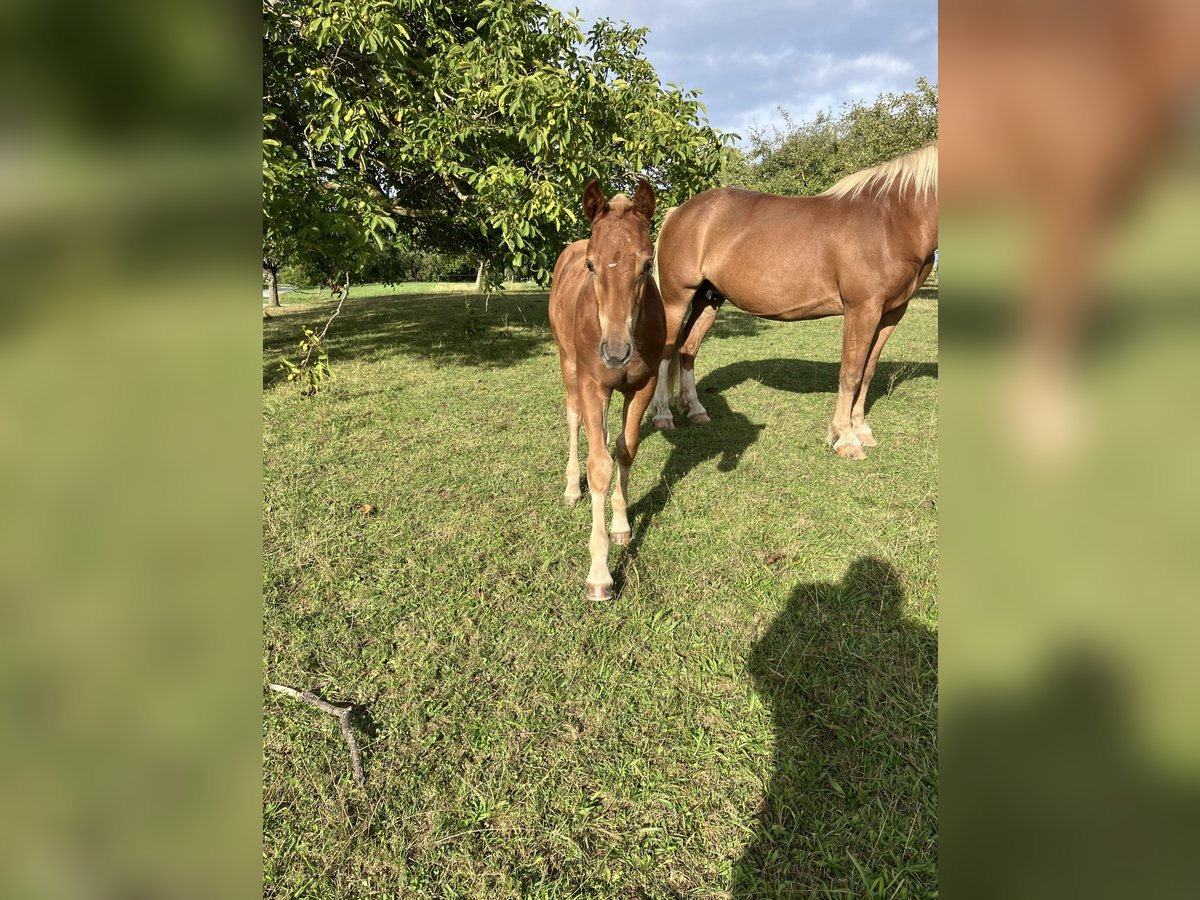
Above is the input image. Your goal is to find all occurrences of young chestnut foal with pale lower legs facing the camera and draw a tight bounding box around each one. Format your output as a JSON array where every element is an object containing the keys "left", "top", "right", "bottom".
[{"left": 550, "top": 179, "right": 666, "bottom": 600}]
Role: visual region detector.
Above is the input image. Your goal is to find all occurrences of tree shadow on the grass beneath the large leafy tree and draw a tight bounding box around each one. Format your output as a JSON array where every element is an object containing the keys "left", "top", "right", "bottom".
[{"left": 263, "top": 293, "right": 554, "bottom": 388}]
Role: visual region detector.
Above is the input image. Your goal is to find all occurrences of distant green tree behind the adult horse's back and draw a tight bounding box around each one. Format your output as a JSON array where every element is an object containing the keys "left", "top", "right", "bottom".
[{"left": 724, "top": 78, "right": 937, "bottom": 196}]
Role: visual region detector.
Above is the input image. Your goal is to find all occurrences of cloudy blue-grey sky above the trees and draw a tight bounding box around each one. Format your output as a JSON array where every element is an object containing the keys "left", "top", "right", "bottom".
[{"left": 551, "top": 0, "right": 937, "bottom": 140}]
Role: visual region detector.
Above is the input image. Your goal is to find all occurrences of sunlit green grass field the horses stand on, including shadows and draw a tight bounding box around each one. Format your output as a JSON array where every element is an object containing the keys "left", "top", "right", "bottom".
[{"left": 263, "top": 289, "right": 937, "bottom": 898}]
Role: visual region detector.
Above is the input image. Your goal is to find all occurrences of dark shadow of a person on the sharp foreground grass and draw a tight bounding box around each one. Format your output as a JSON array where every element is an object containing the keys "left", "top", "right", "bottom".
[{"left": 732, "top": 557, "right": 937, "bottom": 899}]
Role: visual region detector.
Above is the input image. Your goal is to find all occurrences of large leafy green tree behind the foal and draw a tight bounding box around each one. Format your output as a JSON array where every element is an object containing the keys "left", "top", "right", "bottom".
[{"left": 263, "top": 0, "right": 728, "bottom": 280}]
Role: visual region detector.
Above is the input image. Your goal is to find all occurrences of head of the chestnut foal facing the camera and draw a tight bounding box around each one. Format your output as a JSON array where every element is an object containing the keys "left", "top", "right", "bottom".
[{"left": 583, "top": 178, "right": 654, "bottom": 368}]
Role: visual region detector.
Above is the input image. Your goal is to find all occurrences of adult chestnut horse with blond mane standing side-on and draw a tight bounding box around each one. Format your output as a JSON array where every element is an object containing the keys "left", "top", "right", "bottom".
[{"left": 653, "top": 143, "right": 937, "bottom": 460}]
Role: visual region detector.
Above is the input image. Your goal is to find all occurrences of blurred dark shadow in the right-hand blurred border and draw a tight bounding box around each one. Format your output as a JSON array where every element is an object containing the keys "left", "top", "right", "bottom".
[{"left": 941, "top": 642, "right": 1200, "bottom": 900}]
